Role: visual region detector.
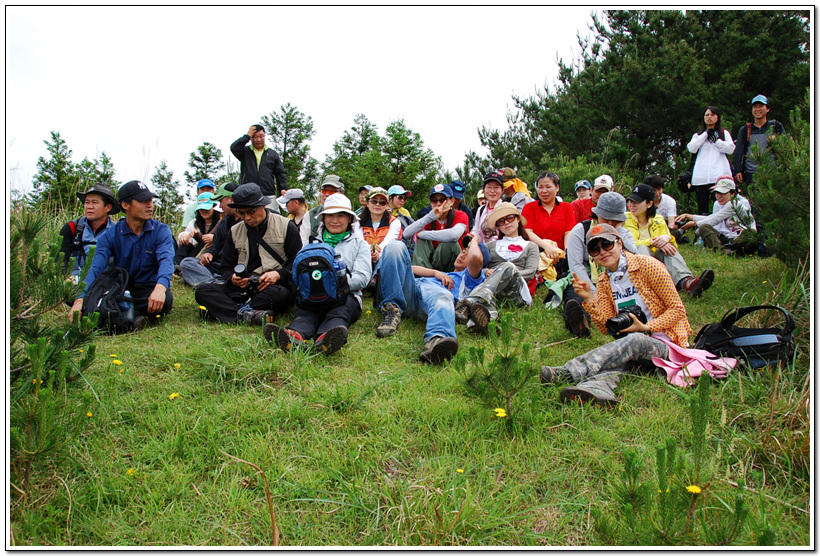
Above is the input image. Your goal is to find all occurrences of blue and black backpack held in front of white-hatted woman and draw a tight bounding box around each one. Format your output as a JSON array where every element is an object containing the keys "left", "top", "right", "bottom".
[{"left": 293, "top": 243, "right": 350, "bottom": 310}]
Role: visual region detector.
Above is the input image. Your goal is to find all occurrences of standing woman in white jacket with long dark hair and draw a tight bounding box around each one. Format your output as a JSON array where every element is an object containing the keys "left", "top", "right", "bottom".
[{"left": 686, "top": 106, "right": 735, "bottom": 215}]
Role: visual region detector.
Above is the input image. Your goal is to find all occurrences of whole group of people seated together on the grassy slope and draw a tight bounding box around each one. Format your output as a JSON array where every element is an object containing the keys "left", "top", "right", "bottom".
[{"left": 61, "top": 160, "right": 755, "bottom": 404}]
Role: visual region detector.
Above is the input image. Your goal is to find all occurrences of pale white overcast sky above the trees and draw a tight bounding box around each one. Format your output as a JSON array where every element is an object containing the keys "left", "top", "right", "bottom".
[{"left": 6, "top": 6, "right": 593, "bottom": 198}]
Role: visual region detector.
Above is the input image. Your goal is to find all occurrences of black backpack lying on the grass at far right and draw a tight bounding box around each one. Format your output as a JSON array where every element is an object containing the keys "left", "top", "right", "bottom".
[{"left": 694, "top": 305, "right": 794, "bottom": 369}]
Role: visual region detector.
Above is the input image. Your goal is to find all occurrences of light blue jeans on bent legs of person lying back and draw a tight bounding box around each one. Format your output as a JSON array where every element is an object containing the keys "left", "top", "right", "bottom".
[{"left": 379, "top": 241, "right": 456, "bottom": 342}]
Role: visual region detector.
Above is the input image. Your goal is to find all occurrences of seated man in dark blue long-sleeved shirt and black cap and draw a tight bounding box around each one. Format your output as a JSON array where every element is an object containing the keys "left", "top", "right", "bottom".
[{"left": 69, "top": 180, "right": 174, "bottom": 329}]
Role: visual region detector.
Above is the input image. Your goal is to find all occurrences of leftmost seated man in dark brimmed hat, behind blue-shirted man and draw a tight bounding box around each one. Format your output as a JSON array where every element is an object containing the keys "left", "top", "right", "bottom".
[{"left": 60, "top": 183, "right": 120, "bottom": 283}]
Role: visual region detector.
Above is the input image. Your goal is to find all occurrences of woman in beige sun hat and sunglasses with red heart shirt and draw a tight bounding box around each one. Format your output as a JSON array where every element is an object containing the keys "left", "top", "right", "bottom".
[{"left": 456, "top": 202, "right": 538, "bottom": 335}]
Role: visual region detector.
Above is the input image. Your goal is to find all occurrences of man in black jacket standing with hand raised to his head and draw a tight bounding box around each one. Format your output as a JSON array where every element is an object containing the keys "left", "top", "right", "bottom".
[{"left": 231, "top": 124, "right": 288, "bottom": 201}]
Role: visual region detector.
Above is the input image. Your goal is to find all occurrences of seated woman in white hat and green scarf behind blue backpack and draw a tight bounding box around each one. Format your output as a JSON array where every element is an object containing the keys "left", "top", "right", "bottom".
[{"left": 264, "top": 193, "right": 372, "bottom": 355}]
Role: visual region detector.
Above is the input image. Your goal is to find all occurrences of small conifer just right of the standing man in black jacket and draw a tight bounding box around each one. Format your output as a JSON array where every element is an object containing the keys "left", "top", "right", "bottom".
[{"left": 262, "top": 103, "right": 318, "bottom": 192}]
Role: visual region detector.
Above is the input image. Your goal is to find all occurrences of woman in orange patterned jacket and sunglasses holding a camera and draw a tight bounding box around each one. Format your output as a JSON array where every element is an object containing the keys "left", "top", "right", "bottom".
[{"left": 541, "top": 224, "right": 692, "bottom": 405}]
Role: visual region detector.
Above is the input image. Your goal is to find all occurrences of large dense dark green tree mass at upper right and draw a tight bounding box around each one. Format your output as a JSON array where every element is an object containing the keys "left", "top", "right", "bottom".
[{"left": 479, "top": 10, "right": 810, "bottom": 177}]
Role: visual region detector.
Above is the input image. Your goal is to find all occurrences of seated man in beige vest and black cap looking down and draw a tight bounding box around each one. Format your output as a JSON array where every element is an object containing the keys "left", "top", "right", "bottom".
[{"left": 195, "top": 183, "right": 302, "bottom": 326}]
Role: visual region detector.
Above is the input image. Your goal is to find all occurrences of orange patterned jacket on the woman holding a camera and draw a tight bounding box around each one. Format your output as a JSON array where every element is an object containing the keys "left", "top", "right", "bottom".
[{"left": 584, "top": 251, "right": 692, "bottom": 347}]
